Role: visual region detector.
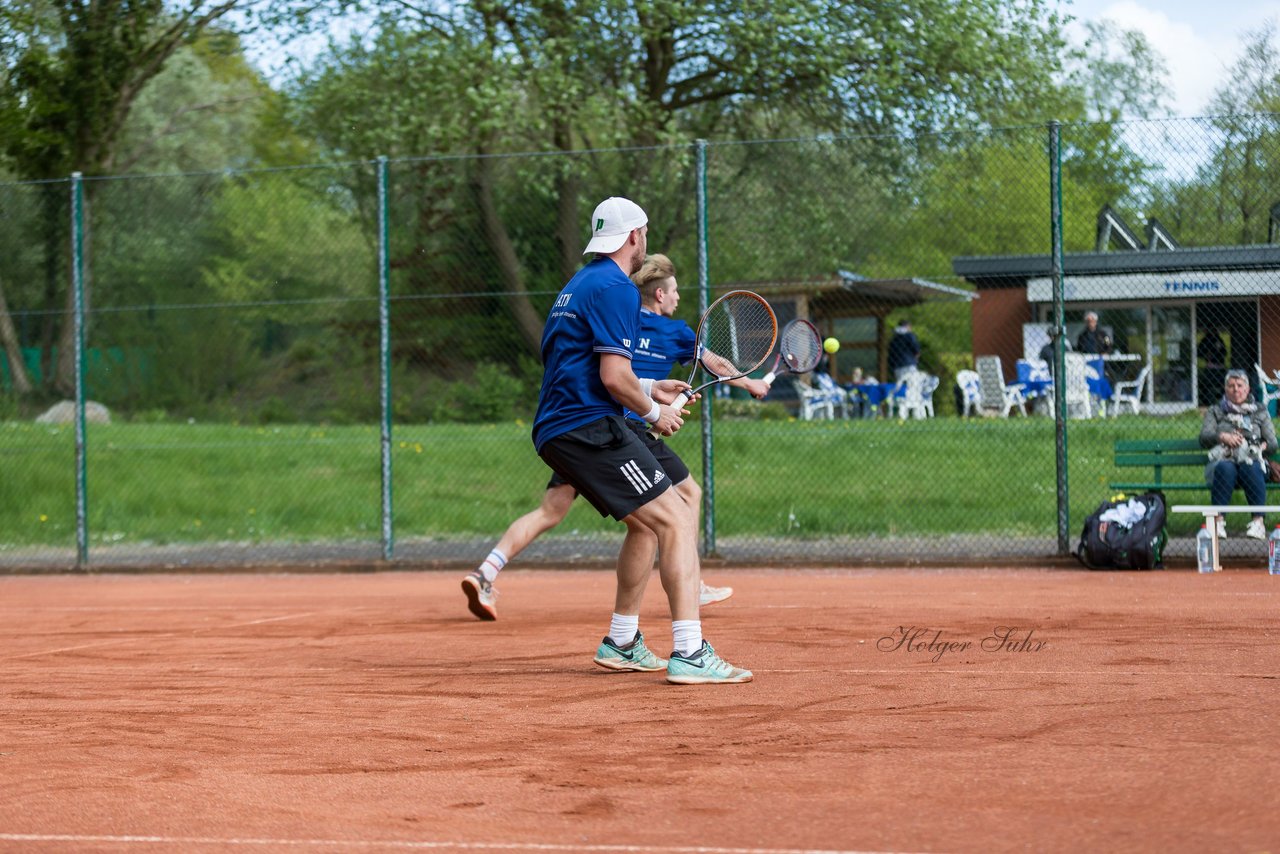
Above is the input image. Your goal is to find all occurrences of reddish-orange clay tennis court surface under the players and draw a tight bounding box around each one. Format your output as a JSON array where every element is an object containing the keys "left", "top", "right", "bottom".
[{"left": 0, "top": 568, "right": 1280, "bottom": 854}]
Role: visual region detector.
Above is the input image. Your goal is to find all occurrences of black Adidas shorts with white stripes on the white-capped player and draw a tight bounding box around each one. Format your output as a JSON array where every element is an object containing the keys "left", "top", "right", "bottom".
[{"left": 539, "top": 415, "right": 689, "bottom": 520}]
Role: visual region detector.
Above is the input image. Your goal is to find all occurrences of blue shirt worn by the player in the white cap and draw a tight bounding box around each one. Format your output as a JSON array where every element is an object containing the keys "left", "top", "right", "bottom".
[{"left": 534, "top": 257, "right": 640, "bottom": 451}]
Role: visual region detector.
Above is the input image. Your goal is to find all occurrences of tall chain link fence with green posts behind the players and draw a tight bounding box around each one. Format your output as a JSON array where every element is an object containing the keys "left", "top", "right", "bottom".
[{"left": 0, "top": 115, "right": 1280, "bottom": 568}]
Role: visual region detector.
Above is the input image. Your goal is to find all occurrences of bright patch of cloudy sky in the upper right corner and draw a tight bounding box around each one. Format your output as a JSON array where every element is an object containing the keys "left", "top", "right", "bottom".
[{"left": 1062, "top": 0, "right": 1280, "bottom": 117}]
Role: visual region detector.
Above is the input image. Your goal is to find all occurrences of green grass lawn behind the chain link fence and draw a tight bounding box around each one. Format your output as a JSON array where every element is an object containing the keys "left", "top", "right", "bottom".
[{"left": 0, "top": 414, "right": 1199, "bottom": 545}]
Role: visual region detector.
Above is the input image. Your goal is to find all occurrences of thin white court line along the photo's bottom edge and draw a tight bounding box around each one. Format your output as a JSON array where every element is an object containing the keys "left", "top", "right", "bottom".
[{"left": 0, "top": 834, "right": 911, "bottom": 854}]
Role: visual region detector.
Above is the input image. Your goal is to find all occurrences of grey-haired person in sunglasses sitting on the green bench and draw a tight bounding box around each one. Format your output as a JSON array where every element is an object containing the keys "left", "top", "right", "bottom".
[{"left": 1199, "top": 369, "right": 1276, "bottom": 539}]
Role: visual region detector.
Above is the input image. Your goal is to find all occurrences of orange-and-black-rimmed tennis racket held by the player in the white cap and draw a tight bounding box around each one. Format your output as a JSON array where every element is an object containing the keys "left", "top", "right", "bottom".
[{"left": 649, "top": 291, "right": 778, "bottom": 439}]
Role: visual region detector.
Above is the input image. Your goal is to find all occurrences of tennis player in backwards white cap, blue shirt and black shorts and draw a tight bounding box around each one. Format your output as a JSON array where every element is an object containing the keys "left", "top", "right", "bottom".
[{"left": 463, "top": 197, "right": 751, "bottom": 684}]
